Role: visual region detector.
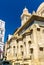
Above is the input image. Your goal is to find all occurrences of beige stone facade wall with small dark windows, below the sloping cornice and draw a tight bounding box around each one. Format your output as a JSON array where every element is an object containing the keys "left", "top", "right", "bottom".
[{"left": 5, "top": 25, "right": 44, "bottom": 65}]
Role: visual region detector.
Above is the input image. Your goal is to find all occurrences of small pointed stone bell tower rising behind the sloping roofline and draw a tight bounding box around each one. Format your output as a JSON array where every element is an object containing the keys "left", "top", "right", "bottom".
[{"left": 21, "top": 7, "right": 31, "bottom": 26}]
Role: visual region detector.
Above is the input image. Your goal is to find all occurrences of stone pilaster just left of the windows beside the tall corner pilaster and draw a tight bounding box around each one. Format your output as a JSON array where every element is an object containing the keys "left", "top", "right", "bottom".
[{"left": 23, "top": 32, "right": 30, "bottom": 58}]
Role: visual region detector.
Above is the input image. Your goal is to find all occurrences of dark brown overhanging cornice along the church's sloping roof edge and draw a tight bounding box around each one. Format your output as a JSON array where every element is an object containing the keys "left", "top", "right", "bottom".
[{"left": 13, "top": 14, "right": 44, "bottom": 35}]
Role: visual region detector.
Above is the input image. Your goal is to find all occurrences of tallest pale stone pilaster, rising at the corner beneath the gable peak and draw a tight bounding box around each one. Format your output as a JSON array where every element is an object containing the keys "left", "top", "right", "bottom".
[{"left": 33, "top": 28, "right": 39, "bottom": 65}]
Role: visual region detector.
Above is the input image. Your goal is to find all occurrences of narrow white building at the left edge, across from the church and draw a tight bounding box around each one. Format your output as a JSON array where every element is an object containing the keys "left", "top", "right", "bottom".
[{"left": 0, "top": 20, "right": 5, "bottom": 59}]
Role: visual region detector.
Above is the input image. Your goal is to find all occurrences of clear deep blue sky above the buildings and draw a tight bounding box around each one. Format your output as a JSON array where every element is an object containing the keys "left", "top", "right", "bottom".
[{"left": 0, "top": 0, "right": 44, "bottom": 41}]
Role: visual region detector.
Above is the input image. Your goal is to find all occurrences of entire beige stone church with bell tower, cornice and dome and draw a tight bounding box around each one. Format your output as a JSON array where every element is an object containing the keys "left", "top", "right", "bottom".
[{"left": 5, "top": 2, "right": 44, "bottom": 65}]
